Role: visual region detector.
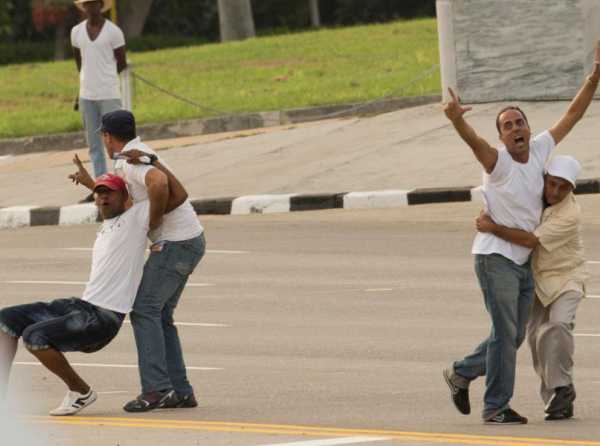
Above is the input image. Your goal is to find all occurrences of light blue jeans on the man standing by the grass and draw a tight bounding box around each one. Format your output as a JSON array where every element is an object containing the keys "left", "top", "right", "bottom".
[{"left": 79, "top": 98, "right": 121, "bottom": 178}]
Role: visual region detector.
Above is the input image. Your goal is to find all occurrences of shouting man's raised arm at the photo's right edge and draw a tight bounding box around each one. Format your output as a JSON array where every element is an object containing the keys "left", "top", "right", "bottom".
[{"left": 550, "top": 42, "right": 600, "bottom": 144}]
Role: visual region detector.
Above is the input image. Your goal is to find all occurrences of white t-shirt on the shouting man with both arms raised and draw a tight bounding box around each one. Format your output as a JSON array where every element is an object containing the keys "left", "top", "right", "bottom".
[{"left": 471, "top": 131, "right": 556, "bottom": 265}]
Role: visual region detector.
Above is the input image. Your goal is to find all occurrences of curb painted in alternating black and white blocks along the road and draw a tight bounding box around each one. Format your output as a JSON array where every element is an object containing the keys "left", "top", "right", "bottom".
[{"left": 0, "top": 179, "right": 600, "bottom": 229}]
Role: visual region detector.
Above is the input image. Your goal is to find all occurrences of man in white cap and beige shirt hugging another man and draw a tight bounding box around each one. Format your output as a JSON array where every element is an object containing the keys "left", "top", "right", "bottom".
[{"left": 476, "top": 155, "right": 587, "bottom": 420}]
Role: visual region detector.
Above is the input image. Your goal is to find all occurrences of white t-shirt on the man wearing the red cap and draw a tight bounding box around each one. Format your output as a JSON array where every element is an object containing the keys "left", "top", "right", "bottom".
[{"left": 82, "top": 201, "right": 150, "bottom": 313}]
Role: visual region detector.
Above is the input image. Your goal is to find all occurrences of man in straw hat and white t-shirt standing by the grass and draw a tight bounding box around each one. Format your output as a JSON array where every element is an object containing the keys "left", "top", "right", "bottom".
[{"left": 71, "top": 0, "right": 127, "bottom": 202}]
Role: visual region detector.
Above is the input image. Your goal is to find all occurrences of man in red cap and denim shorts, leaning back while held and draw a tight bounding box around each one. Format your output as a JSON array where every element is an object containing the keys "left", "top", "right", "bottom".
[{"left": 0, "top": 164, "right": 187, "bottom": 416}]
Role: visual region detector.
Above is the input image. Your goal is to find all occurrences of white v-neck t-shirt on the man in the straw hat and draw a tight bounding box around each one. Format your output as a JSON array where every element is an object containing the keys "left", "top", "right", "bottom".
[{"left": 71, "top": 20, "right": 125, "bottom": 101}]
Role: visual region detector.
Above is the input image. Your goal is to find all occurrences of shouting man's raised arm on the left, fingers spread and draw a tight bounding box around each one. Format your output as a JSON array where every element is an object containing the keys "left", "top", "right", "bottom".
[{"left": 444, "top": 88, "right": 498, "bottom": 173}]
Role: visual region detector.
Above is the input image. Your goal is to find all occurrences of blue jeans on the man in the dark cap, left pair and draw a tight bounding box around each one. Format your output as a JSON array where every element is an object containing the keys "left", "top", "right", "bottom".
[{"left": 130, "top": 235, "right": 206, "bottom": 395}]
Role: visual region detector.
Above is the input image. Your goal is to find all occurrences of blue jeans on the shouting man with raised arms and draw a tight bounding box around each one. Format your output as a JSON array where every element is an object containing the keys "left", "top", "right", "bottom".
[{"left": 454, "top": 254, "right": 534, "bottom": 419}]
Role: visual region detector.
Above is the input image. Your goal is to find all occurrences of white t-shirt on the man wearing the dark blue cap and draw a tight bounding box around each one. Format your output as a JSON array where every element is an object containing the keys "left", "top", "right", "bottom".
[{"left": 115, "top": 137, "right": 204, "bottom": 242}]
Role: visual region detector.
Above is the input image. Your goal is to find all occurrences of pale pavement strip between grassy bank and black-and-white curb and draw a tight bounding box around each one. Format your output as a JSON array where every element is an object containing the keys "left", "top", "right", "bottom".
[{"left": 0, "top": 102, "right": 600, "bottom": 207}]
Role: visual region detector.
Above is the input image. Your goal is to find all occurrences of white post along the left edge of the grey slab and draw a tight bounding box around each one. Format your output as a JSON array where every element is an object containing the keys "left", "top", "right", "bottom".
[{"left": 435, "top": 0, "right": 458, "bottom": 102}]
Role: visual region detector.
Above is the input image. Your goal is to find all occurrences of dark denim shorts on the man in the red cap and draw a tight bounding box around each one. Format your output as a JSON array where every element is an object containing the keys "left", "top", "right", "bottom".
[{"left": 0, "top": 297, "right": 125, "bottom": 353}]
